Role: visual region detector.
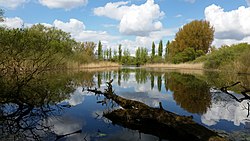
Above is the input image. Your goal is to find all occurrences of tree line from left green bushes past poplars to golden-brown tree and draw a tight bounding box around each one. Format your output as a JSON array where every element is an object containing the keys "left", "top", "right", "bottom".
[{"left": 0, "top": 10, "right": 214, "bottom": 72}]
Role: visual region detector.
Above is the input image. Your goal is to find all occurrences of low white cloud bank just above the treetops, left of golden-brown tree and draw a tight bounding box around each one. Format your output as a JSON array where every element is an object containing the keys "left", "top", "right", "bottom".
[{"left": 0, "top": 17, "right": 174, "bottom": 55}]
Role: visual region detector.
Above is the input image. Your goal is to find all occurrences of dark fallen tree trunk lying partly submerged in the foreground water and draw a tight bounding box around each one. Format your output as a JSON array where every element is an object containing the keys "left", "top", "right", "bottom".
[{"left": 88, "top": 82, "right": 224, "bottom": 141}]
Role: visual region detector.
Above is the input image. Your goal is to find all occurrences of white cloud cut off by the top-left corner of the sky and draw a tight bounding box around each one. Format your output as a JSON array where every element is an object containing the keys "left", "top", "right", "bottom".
[{"left": 0, "top": 0, "right": 29, "bottom": 9}]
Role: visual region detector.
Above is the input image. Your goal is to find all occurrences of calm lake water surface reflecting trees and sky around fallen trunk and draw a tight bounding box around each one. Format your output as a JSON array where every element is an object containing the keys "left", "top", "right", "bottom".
[{"left": 0, "top": 68, "right": 250, "bottom": 141}]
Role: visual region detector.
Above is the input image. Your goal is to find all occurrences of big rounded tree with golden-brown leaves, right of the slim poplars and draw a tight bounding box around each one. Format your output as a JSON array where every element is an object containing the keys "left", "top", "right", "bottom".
[{"left": 169, "top": 20, "right": 214, "bottom": 63}]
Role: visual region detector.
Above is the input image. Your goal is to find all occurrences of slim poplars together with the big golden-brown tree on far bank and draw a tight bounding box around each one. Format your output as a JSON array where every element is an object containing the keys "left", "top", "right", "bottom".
[{"left": 95, "top": 20, "right": 214, "bottom": 66}]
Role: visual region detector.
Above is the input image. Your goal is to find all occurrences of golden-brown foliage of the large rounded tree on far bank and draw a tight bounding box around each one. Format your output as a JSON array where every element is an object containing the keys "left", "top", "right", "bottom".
[{"left": 169, "top": 20, "right": 214, "bottom": 62}]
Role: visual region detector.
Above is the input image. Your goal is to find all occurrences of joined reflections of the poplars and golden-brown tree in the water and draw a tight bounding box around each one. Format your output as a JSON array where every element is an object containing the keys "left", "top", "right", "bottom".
[{"left": 100, "top": 69, "right": 211, "bottom": 114}]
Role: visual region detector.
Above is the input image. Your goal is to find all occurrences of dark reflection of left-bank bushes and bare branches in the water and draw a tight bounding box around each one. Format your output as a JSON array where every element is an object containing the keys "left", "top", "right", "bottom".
[{"left": 0, "top": 73, "right": 94, "bottom": 140}]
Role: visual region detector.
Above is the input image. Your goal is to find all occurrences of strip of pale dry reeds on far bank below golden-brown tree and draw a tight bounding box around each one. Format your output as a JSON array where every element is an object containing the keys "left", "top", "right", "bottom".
[{"left": 143, "top": 63, "right": 203, "bottom": 70}]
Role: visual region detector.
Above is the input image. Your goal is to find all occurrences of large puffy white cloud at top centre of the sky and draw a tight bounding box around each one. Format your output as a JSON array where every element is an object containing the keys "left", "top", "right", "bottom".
[{"left": 94, "top": 0, "right": 164, "bottom": 36}]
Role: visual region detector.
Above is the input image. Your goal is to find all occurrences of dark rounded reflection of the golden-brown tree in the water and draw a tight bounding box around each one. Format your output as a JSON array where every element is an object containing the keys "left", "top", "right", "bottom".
[{"left": 167, "top": 73, "right": 211, "bottom": 114}]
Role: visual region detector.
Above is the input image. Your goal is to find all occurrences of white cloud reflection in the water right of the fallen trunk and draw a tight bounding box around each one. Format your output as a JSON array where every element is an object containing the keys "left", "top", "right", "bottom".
[{"left": 201, "top": 93, "right": 248, "bottom": 126}]
